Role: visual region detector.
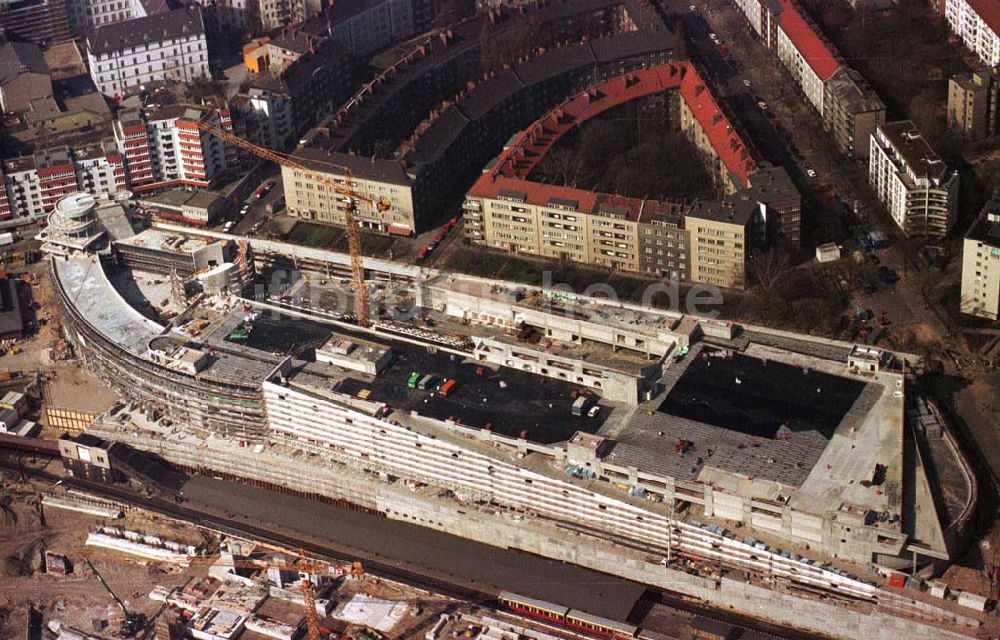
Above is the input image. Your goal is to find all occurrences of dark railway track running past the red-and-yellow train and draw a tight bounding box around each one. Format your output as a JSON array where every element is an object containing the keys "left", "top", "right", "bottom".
[{"left": 0, "top": 438, "right": 804, "bottom": 640}]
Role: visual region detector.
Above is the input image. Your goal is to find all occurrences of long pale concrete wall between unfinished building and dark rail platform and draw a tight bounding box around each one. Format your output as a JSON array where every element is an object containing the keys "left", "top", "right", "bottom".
[{"left": 86, "top": 425, "right": 973, "bottom": 640}]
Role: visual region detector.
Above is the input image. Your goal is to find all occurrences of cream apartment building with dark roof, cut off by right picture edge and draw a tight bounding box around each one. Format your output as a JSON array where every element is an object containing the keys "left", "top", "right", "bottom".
[{"left": 960, "top": 192, "right": 1000, "bottom": 320}]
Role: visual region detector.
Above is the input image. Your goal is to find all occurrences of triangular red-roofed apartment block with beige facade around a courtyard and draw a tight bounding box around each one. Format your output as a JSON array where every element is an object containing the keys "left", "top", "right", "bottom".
[{"left": 464, "top": 62, "right": 800, "bottom": 287}]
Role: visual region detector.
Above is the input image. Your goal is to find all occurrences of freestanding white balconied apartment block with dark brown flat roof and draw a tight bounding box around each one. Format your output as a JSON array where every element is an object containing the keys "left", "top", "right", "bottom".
[{"left": 868, "top": 120, "right": 958, "bottom": 237}]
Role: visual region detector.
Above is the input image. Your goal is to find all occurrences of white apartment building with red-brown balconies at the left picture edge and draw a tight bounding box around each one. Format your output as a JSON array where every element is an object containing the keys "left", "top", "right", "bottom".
[{"left": 0, "top": 140, "right": 126, "bottom": 220}]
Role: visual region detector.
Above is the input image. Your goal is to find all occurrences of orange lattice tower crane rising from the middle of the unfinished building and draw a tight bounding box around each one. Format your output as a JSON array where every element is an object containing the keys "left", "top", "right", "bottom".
[{"left": 198, "top": 122, "right": 374, "bottom": 328}]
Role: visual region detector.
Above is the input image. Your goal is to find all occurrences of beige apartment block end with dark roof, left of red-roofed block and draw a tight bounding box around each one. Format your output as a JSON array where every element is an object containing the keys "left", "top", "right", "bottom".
[{"left": 281, "top": 147, "right": 416, "bottom": 235}]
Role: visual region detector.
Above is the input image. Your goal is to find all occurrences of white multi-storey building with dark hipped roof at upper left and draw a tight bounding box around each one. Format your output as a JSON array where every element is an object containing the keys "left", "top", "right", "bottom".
[{"left": 87, "top": 7, "right": 210, "bottom": 98}]
